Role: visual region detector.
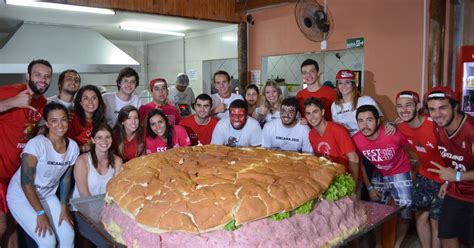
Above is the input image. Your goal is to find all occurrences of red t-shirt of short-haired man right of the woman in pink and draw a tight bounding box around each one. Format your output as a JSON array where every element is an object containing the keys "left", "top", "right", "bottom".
[{"left": 179, "top": 115, "right": 218, "bottom": 146}]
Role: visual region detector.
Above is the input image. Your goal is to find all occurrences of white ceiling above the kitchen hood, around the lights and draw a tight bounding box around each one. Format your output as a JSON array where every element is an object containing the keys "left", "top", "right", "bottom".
[{"left": 0, "top": 0, "right": 232, "bottom": 42}]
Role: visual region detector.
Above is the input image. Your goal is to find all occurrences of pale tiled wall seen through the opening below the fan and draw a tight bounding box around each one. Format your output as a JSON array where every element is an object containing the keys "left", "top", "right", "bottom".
[{"left": 261, "top": 48, "right": 364, "bottom": 94}]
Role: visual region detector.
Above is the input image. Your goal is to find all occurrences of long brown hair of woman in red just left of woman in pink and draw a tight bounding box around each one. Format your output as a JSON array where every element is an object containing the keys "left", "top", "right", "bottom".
[{"left": 113, "top": 105, "right": 145, "bottom": 161}]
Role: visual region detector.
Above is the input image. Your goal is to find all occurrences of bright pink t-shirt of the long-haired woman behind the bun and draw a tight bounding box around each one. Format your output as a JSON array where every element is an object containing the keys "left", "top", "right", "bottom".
[{"left": 146, "top": 125, "right": 191, "bottom": 154}]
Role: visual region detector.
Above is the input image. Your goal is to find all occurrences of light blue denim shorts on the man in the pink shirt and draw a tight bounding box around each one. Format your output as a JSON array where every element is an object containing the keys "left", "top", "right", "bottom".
[{"left": 372, "top": 172, "right": 413, "bottom": 219}]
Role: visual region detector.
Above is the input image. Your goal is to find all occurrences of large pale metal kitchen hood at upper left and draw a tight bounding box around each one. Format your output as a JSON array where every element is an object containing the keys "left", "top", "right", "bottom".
[{"left": 0, "top": 23, "right": 140, "bottom": 73}]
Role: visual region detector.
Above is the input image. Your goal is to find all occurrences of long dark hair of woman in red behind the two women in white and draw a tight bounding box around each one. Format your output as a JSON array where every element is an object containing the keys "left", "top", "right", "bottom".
[{"left": 74, "top": 84, "right": 105, "bottom": 126}]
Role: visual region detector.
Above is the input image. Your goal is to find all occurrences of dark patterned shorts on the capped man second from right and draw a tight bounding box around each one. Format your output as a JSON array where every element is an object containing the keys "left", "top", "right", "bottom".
[{"left": 412, "top": 173, "right": 443, "bottom": 220}]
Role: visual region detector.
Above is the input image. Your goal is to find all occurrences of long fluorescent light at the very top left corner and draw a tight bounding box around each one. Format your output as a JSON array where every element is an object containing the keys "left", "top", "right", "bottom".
[{"left": 6, "top": 0, "right": 115, "bottom": 15}]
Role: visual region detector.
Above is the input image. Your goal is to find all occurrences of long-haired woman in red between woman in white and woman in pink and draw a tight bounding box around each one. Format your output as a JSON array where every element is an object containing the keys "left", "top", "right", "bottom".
[{"left": 113, "top": 105, "right": 145, "bottom": 163}]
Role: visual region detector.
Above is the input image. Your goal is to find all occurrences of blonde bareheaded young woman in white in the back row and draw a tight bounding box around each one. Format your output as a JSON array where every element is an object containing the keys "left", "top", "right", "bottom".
[{"left": 255, "top": 80, "right": 283, "bottom": 123}]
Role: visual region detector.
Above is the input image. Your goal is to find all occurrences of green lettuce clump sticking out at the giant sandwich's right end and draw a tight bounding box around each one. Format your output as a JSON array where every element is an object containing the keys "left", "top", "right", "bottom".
[{"left": 323, "top": 174, "right": 356, "bottom": 201}]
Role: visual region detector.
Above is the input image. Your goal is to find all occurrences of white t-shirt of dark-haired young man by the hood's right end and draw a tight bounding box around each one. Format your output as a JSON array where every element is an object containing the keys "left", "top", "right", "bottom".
[{"left": 102, "top": 92, "right": 142, "bottom": 128}]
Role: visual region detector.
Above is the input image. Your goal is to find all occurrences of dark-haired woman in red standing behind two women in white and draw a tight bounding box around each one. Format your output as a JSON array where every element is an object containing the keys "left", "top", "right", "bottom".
[{"left": 67, "top": 85, "right": 106, "bottom": 153}]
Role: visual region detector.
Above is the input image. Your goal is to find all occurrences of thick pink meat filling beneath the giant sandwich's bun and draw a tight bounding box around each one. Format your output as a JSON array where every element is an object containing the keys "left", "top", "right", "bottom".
[{"left": 102, "top": 197, "right": 367, "bottom": 247}]
